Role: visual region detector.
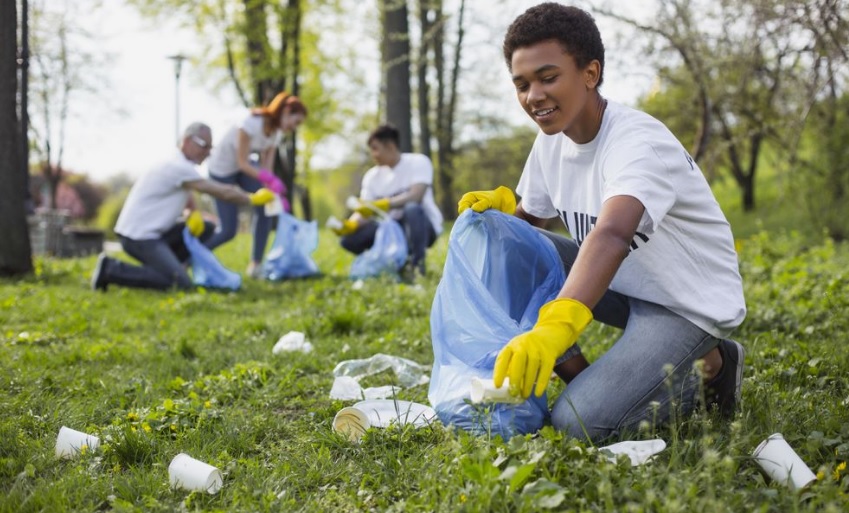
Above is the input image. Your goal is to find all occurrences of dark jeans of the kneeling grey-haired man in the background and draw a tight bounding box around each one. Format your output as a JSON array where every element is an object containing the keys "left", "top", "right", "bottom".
[{"left": 104, "top": 222, "right": 215, "bottom": 290}]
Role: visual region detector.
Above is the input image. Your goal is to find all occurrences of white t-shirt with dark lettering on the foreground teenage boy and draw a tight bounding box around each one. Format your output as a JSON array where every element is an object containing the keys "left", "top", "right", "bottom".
[{"left": 517, "top": 102, "right": 746, "bottom": 337}]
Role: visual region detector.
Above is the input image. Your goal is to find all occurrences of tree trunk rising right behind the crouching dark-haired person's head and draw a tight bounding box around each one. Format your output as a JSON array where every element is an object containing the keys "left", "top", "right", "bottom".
[{"left": 382, "top": 0, "right": 413, "bottom": 152}]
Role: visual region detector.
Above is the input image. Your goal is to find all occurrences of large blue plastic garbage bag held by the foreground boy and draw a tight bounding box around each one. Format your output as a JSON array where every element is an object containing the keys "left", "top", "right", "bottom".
[{"left": 428, "top": 209, "right": 566, "bottom": 440}]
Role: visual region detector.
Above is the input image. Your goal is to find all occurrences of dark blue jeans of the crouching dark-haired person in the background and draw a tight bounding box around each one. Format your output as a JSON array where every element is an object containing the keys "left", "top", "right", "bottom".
[{"left": 341, "top": 203, "right": 436, "bottom": 273}]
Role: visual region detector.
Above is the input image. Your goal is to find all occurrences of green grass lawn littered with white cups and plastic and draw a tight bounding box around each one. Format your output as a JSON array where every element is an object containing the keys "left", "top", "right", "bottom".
[{"left": 0, "top": 226, "right": 849, "bottom": 512}]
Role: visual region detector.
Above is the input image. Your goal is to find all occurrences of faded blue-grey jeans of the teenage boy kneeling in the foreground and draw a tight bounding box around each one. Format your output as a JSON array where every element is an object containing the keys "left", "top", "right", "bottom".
[{"left": 540, "top": 230, "right": 719, "bottom": 441}]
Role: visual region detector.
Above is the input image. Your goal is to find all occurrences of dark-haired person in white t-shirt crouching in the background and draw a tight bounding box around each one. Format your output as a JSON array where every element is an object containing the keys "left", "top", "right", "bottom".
[{"left": 334, "top": 124, "right": 442, "bottom": 277}]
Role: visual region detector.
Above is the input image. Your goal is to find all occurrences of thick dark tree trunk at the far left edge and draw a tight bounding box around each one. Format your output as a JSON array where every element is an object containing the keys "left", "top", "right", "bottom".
[{"left": 0, "top": 2, "right": 32, "bottom": 276}]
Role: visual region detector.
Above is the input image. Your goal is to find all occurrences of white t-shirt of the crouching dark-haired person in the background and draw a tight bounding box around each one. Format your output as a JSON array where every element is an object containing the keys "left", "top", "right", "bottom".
[{"left": 360, "top": 153, "right": 442, "bottom": 235}]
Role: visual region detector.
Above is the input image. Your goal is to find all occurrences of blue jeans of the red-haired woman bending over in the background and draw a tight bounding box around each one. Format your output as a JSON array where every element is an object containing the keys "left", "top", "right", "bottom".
[{"left": 205, "top": 171, "right": 271, "bottom": 262}]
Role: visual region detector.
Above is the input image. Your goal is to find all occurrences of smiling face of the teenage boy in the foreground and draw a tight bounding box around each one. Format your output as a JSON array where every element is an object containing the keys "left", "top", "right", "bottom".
[{"left": 510, "top": 39, "right": 601, "bottom": 144}]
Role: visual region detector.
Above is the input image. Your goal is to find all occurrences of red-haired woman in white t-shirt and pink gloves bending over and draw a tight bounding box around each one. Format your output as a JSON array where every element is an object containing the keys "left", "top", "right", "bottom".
[{"left": 206, "top": 92, "right": 307, "bottom": 277}]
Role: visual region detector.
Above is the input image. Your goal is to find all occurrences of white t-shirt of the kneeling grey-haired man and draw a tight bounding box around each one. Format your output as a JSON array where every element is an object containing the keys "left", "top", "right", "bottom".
[{"left": 115, "top": 151, "right": 203, "bottom": 240}]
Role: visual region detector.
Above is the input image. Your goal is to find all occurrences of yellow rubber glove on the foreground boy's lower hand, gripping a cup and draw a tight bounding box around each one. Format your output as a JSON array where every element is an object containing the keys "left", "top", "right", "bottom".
[{"left": 492, "top": 299, "right": 593, "bottom": 399}]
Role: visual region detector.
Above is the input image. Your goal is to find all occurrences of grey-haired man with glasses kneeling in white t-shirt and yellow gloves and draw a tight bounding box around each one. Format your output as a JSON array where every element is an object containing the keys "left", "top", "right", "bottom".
[{"left": 91, "top": 123, "right": 273, "bottom": 291}]
